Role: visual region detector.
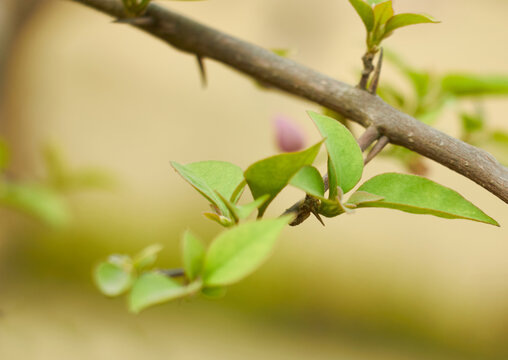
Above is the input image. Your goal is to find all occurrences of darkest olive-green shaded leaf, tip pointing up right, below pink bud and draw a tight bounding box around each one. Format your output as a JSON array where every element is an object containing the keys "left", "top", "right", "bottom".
[{"left": 245, "top": 141, "right": 323, "bottom": 217}]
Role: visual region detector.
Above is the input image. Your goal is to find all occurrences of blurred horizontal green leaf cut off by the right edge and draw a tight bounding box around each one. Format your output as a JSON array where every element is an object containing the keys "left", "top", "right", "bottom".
[{"left": 441, "top": 74, "right": 508, "bottom": 96}]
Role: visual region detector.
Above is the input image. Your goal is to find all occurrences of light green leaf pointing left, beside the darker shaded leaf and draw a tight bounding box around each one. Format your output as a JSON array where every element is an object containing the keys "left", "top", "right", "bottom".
[{"left": 171, "top": 161, "right": 243, "bottom": 217}]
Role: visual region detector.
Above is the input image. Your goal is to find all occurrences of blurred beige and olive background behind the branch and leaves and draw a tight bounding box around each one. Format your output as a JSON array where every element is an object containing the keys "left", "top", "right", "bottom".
[{"left": 0, "top": 0, "right": 508, "bottom": 360}]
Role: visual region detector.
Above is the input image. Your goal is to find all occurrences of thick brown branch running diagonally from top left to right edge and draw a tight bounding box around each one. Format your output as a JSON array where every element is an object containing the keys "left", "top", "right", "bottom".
[{"left": 72, "top": 0, "right": 508, "bottom": 202}]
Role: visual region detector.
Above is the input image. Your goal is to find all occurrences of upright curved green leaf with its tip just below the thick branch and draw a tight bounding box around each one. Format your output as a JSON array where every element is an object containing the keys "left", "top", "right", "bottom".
[{"left": 308, "top": 111, "right": 363, "bottom": 194}]
